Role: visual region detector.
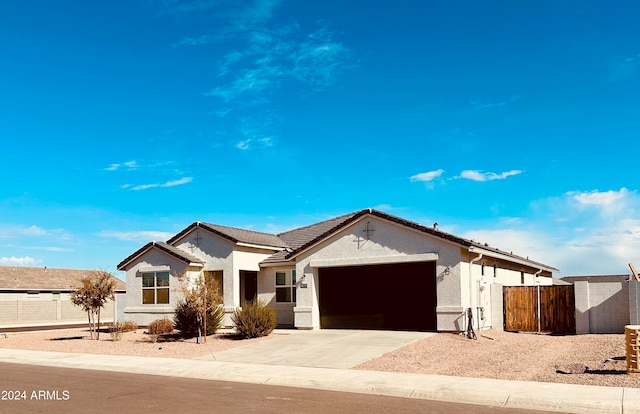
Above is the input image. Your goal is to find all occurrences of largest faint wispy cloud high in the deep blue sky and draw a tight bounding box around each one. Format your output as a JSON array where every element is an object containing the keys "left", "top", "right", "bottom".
[{"left": 195, "top": 6, "right": 353, "bottom": 103}]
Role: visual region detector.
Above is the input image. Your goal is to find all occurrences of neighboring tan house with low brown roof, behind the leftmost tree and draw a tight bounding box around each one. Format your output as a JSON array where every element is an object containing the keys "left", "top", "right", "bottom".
[{"left": 0, "top": 266, "right": 126, "bottom": 326}]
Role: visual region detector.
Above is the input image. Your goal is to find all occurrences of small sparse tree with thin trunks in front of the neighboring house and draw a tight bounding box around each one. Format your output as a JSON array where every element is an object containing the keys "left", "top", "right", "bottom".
[{"left": 71, "top": 270, "right": 116, "bottom": 339}]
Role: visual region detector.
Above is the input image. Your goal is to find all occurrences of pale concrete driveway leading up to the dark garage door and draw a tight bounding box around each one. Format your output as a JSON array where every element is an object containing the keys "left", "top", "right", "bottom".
[{"left": 198, "top": 330, "right": 435, "bottom": 368}]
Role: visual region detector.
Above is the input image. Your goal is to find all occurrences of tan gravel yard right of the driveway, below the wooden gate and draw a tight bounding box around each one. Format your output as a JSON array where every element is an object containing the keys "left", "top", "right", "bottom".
[{"left": 356, "top": 331, "right": 640, "bottom": 388}]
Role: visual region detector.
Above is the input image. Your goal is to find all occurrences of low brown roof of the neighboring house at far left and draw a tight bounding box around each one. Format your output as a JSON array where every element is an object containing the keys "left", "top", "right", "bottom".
[{"left": 0, "top": 266, "right": 126, "bottom": 291}]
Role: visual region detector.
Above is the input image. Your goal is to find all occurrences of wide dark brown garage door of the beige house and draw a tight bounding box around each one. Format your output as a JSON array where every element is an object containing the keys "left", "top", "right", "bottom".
[{"left": 318, "top": 262, "right": 436, "bottom": 331}]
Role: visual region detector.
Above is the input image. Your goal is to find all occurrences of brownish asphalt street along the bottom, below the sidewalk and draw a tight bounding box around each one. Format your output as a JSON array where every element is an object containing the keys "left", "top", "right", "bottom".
[{"left": 0, "top": 363, "right": 564, "bottom": 414}]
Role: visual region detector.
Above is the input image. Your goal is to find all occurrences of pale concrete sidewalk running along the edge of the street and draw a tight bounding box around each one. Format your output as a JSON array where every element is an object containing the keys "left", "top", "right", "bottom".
[{"left": 0, "top": 349, "right": 640, "bottom": 414}]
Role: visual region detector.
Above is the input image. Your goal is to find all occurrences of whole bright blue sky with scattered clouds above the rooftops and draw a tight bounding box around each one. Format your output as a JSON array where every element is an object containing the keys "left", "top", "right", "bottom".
[{"left": 0, "top": 0, "right": 640, "bottom": 277}]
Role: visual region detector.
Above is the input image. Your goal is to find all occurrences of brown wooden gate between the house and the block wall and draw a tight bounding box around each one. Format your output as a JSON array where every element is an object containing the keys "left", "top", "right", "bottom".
[{"left": 503, "top": 285, "right": 576, "bottom": 334}]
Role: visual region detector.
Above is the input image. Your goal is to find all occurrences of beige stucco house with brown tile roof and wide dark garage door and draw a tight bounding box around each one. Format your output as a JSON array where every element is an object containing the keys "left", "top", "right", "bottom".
[{"left": 118, "top": 209, "right": 558, "bottom": 331}]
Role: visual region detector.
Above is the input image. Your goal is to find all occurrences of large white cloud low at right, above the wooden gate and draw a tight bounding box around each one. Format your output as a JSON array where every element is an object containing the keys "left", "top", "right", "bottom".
[{"left": 460, "top": 188, "right": 640, "bottom": 276}]
